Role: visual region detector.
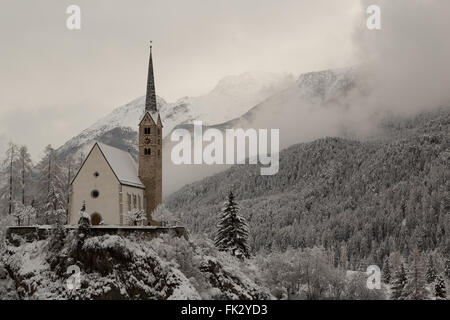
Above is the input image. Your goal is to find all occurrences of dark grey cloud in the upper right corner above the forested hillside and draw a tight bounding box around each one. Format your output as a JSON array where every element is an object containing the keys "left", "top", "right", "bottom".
[{"left": 354, "top": 0, "right": 450, "bottom": 115}]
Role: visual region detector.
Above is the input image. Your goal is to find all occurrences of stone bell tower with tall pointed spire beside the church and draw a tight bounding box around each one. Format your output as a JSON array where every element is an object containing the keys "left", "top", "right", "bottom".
[{"left": 139, "top": 44, "right": 163, "bottom": 225}]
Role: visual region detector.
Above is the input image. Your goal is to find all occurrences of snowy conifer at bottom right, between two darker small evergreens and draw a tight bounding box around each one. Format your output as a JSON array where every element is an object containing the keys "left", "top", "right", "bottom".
[{"left": 403, "top": 250, "right": 427, "bottom": 300}]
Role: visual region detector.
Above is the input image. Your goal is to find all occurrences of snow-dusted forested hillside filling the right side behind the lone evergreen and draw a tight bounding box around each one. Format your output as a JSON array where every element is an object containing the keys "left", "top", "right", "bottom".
[{"left": 167, "top": 107, "right": 450, "bottom": 269}]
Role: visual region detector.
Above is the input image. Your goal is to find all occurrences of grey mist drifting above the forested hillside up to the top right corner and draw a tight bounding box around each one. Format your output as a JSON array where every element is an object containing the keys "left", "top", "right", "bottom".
[{"left": 165, "top": 0, "right": 450, "bottom": 193}]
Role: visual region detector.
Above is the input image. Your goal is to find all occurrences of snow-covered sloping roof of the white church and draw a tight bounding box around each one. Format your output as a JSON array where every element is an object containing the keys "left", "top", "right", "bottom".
[{"left": 96, "top": 142, "right": 145, "bottom": 188}]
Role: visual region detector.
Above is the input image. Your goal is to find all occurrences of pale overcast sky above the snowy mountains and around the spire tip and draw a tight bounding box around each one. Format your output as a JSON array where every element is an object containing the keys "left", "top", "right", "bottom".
[{"left": 0, "top": 0, "right": 365, "bottom": 157}]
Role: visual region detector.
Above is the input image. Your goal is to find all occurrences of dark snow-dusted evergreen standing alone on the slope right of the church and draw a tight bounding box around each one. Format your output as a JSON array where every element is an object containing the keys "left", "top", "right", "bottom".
[{"left": 214, "top": 191, "right": 250, "bottom": 259}]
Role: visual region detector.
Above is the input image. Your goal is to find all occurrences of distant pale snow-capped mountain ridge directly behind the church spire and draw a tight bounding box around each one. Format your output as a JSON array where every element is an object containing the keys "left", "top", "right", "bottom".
[{"left": 59, "top": 72, "right": 295, "bottom": 156}]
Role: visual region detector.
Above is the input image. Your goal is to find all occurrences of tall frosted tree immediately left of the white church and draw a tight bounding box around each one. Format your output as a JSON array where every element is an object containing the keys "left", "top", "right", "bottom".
[{"left": 38, "top": 145, "right": 67, "bottom": 224}]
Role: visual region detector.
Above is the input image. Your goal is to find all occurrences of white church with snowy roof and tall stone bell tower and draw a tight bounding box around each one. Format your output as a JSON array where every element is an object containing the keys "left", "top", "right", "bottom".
[{"left": 69, "top": 46, "right": 163, "bottom": 225}]
